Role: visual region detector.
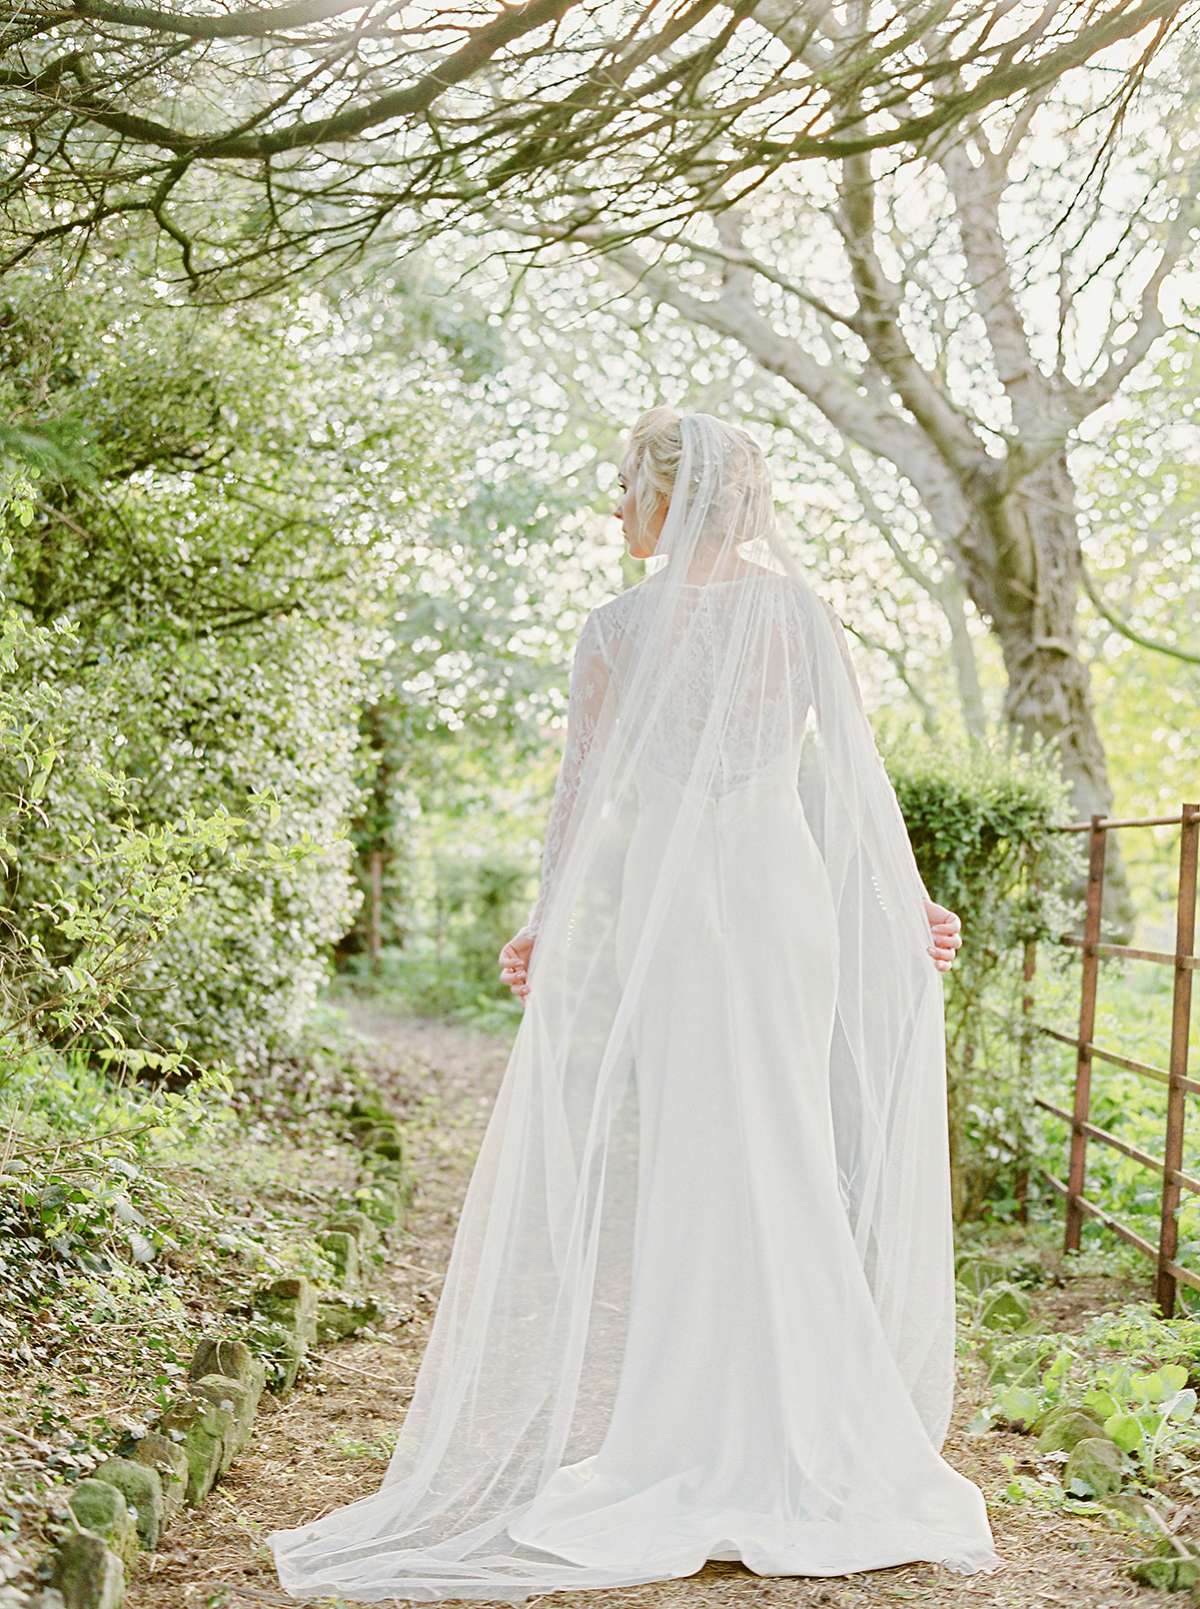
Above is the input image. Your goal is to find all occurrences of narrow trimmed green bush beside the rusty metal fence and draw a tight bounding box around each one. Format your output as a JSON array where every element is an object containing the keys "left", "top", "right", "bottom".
[{"left": 885, "top": 740, "right": 1078, "bottom": 1218}]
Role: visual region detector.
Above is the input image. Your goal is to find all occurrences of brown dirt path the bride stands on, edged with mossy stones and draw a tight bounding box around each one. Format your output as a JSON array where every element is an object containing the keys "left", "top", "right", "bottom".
[{"left": 127, "top": 1010, "right": 1155, "bottom": 1609}]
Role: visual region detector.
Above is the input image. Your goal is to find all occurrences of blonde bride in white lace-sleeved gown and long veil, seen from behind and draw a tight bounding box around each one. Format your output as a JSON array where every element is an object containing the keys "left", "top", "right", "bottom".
[{"left": 272, "top": 409, "right": 996, "bottom": 1601}]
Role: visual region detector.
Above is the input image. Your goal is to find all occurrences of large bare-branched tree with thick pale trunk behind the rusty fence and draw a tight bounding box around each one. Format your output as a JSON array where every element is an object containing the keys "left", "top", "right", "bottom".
[{"left": 550, "top": 56, "right": 1200, "bottom": 888}]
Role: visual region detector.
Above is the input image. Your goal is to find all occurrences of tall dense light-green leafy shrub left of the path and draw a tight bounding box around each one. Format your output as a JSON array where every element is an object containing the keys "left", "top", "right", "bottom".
[{"left": 0, "top": 261, "right": 454, "bottom": 1067}]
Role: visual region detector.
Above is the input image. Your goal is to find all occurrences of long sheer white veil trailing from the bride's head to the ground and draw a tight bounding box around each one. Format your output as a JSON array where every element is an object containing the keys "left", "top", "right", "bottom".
[{"left": 272, "top": 415, "right": 965, "bottom": 1601}]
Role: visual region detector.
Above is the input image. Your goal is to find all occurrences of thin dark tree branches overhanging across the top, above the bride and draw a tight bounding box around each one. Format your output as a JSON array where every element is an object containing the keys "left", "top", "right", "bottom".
[{"left": 0, "top": 0, "right": 1195, "bottom": 285}]
